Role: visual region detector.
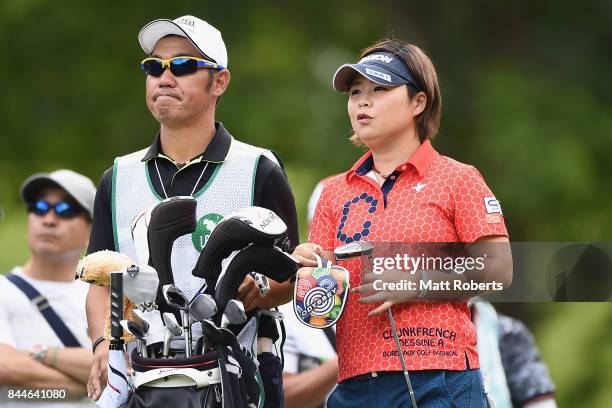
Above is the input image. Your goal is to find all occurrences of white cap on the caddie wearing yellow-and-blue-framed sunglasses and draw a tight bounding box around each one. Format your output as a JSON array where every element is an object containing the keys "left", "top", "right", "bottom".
[{"left": 138, "top": 16, "right": 228, "bottom": 68}]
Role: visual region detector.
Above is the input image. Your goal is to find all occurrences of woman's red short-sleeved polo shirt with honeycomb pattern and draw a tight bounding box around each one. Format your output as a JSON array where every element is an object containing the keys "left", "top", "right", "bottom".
[{"left": 309, "top": 141, "right": 507, "bottom": 381}]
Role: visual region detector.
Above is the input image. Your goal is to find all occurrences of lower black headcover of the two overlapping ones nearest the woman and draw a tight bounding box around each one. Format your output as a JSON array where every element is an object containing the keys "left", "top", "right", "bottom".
[{"left": 214, "top": 244, "right": 300, "bottom": 324}]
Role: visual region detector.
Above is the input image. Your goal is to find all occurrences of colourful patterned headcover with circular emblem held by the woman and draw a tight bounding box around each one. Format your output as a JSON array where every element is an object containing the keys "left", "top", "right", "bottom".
[{"left": 293, "top": 258, "right": 350, "bottom": 329}]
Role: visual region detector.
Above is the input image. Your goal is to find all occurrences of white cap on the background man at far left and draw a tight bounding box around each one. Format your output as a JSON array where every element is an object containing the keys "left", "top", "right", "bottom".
[{"left": 21, "top": 169, "right": 96, "bottom": 219}]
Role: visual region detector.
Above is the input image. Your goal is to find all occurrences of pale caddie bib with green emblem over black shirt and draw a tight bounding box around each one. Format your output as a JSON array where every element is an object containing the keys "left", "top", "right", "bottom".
[{"left": 112, "top": 138, "right": 278, "bottom": 299}]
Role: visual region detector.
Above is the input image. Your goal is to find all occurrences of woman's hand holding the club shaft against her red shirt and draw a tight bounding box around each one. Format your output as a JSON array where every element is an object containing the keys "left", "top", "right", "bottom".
[{"left": 352, "top": 270, "right": 420, "bottom": 316}]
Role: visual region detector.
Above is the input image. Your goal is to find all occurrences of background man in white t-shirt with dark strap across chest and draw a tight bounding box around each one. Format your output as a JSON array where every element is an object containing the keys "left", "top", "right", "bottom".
[{"left": 0, "top": 170, "right": 96, "bottom": 407}]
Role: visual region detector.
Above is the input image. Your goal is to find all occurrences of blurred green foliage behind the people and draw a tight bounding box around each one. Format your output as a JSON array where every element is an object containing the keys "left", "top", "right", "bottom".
[{"left": 0, "top": 0, "right": 612, "bottom": 407}]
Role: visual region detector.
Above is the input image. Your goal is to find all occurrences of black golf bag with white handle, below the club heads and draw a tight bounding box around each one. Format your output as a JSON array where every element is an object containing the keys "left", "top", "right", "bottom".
[{"left": 124, "top": 308, "right": 265, "bottom": 408}]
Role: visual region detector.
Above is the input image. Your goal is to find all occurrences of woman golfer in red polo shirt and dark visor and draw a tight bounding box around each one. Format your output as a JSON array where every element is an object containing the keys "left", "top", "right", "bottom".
[{"left": 295, "top": 40, "right": 512, "bottom": 408}]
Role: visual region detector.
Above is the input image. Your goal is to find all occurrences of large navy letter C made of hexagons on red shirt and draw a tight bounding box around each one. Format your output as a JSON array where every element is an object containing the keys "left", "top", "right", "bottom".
[{"left": 336, "top": 193, "right": 378, "bottom": 244}]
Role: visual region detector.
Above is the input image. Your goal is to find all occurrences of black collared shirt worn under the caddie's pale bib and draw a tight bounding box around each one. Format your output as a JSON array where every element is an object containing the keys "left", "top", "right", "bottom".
[{"left": 87, "top": 122, "right": 299, "bottom": 254}]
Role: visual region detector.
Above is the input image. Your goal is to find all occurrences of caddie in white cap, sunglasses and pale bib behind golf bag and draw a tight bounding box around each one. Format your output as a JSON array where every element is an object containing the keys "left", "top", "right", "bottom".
[{"left": 87, "top": 16, "right": 298, "bottom": 406}]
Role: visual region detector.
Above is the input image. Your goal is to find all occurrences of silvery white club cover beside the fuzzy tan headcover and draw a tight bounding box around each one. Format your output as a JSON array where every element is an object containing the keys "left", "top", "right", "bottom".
[{"left": 123, "top": 265, "right": 159, "bottom": 308}]
